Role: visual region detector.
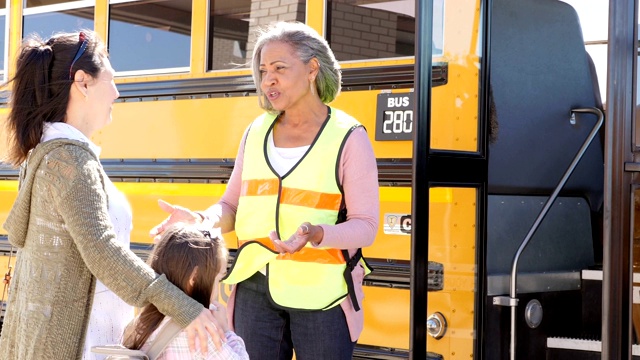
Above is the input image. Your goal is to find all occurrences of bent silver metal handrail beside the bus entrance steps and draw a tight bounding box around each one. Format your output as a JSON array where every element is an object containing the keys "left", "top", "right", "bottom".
[{"left": 493, "top": 107, "right": 604, "bottom": 360}]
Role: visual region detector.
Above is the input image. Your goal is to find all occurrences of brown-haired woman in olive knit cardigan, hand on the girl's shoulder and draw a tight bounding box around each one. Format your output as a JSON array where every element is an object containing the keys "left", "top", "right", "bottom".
[{"left": 0, "top": 30, "right": 222, "bottom": 360}]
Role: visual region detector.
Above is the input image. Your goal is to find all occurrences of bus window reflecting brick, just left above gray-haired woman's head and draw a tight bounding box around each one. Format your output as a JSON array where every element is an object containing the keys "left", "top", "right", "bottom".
[{"left": 207, "top": 0, "right": 306, "bottom": 70}]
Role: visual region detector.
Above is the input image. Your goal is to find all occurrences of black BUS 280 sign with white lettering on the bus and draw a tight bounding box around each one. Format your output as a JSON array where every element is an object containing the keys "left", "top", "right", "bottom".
[{"left": 376, "top": 92, "right": 414, "bottom": 141}]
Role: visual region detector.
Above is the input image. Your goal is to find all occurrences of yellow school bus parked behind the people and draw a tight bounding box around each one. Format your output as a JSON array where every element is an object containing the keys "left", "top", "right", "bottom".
[{"left": 0, "top": 0, "right": 640, "bottom": 359}]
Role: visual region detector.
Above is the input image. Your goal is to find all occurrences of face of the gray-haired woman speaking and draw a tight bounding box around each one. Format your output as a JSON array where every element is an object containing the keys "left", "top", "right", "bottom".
[{"left": 260, "top": 41, "right": 318, "bottom": 111}]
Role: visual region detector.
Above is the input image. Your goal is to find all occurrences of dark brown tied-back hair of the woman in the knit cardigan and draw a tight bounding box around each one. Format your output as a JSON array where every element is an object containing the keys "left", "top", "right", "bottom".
[{"left": 5, "top": 30, "right": 108, "bottom": 166}]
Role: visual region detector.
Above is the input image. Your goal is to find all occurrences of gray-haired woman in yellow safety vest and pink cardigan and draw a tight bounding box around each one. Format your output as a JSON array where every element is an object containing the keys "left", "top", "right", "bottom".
[{"left": 151, "top": 22, "right": 379, "bottom": 360}]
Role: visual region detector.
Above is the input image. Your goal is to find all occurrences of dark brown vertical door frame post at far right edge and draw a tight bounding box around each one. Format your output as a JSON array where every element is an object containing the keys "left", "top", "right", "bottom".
[{"left": 601, "top": 0, "right": 638, "bottom": 360}]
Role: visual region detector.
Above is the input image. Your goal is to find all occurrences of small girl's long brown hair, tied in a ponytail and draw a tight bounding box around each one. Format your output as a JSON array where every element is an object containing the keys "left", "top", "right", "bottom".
[{"left": 123, "top": 224, "right": 227, "bottom": 350}]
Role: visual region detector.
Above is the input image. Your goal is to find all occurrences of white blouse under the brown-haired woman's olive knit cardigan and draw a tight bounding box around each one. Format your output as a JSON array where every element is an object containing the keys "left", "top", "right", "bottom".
[{"left": 41, "top": 122, "right": 134, "bottom": 360}]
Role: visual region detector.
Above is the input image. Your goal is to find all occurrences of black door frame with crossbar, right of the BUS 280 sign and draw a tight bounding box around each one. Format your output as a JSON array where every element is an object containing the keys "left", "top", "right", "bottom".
[{"left": 409, "top": 0, "right": 490, "bottom": 360}]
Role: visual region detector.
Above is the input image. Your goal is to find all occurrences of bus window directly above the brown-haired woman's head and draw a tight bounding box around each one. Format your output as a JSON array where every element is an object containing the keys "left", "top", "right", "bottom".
[{"left": 22, "top": 0, "right": 94, "bottom": 38}]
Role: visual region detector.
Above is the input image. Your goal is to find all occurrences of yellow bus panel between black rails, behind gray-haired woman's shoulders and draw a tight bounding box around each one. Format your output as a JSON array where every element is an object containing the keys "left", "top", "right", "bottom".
[{"left": 92, "top": 91, "right": 412, "bottom": 159}]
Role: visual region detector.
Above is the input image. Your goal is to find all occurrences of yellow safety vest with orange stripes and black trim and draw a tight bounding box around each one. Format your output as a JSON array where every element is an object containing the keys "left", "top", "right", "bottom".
[{"left": 224, "top": 108, "right": 368, "bottom": 310}]
